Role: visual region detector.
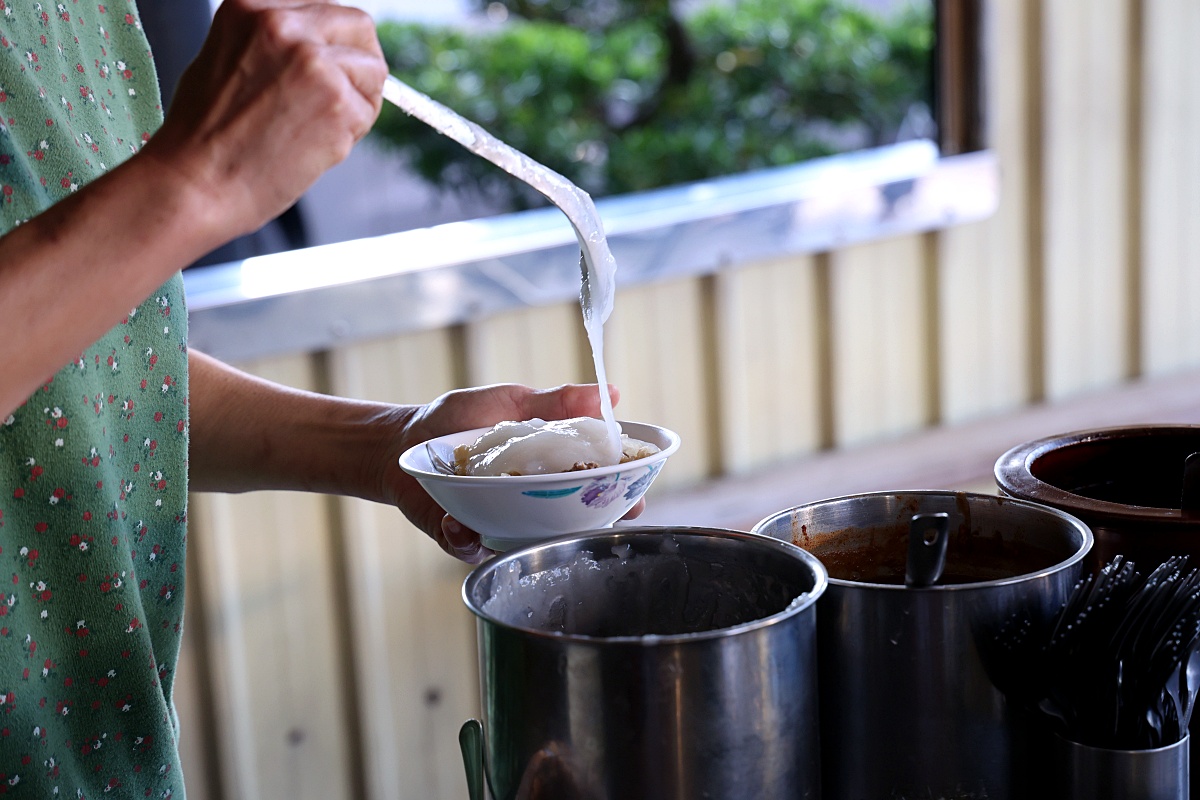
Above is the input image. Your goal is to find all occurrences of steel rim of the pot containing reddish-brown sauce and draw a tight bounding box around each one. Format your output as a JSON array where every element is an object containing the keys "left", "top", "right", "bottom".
[{"left": 752, "top": 489, "right": 1096, "bottom": 594}]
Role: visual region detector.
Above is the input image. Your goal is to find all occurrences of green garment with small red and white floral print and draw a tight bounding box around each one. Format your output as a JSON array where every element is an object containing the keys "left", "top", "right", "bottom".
[{"left": 0, "top": 0, "right": 187, "bottom": 800}]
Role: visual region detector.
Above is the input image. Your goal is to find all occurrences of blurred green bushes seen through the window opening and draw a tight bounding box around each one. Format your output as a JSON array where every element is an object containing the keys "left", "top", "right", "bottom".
[{"left": 376, "top": 0, "right": 934, "bottom": 207}]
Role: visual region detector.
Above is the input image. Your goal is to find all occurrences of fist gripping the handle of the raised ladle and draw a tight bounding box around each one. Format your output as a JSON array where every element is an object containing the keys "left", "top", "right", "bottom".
[{"left": 143, "top": 0, "right": 388, "bottom": 243}]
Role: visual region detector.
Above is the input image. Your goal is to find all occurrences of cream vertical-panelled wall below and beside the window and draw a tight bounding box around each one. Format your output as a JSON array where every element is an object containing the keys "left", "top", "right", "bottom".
[{"left": 178, "top": 0, "right": 1200, "bottom": 800}]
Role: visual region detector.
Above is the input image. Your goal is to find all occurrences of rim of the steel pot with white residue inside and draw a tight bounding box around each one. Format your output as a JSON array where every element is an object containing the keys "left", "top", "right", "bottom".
[{"left": 461, "top": 525, "right": 829, "bottom": 646}]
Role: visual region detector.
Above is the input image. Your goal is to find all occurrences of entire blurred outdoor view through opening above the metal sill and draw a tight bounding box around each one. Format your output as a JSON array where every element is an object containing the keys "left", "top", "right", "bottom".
[{"left": 157, "top": 0, "right": 935, "bottom": 253}]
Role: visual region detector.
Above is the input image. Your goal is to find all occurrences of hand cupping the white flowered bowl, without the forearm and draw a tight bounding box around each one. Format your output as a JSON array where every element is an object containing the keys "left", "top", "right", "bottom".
[{"left": 382, "top": 384, "right": 646, "bottom": 564}]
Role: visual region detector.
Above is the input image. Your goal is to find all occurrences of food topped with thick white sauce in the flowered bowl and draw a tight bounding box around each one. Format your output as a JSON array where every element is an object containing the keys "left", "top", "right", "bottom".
[{"left": 454, "top": 416, "right": 659, "bottom": 476}]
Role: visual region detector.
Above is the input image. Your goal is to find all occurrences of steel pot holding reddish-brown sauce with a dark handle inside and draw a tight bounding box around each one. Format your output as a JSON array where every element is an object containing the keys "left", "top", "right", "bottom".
[{"left": 754, "top": 492, "right": 1092, "bottom": 800}]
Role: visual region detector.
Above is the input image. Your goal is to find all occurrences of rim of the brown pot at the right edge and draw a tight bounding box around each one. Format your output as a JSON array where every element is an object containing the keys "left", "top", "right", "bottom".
[{"left": 992, "top": 423, "right": 1200, "bottom": 525}]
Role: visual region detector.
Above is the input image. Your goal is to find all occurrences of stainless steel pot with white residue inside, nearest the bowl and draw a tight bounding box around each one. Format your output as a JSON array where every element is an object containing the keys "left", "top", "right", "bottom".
[{"left": 463, "top": 528, "right": 827, "bottom": 800}]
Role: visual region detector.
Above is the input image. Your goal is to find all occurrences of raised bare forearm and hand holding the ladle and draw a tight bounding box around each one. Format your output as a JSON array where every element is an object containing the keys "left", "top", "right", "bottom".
[{"left": 0, "top": 0, "right": 386, "bottom": 419}]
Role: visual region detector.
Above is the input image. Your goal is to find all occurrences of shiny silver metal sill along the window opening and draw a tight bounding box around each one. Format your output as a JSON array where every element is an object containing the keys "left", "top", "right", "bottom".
[{"left": 185, "top": 140, "right": 1000, "bottom": 361}]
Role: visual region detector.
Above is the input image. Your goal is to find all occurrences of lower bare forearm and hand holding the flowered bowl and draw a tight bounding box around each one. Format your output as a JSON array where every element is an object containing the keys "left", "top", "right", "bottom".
[{"left": 188, "top": 350, "right": 642, "bottom": 561}]
